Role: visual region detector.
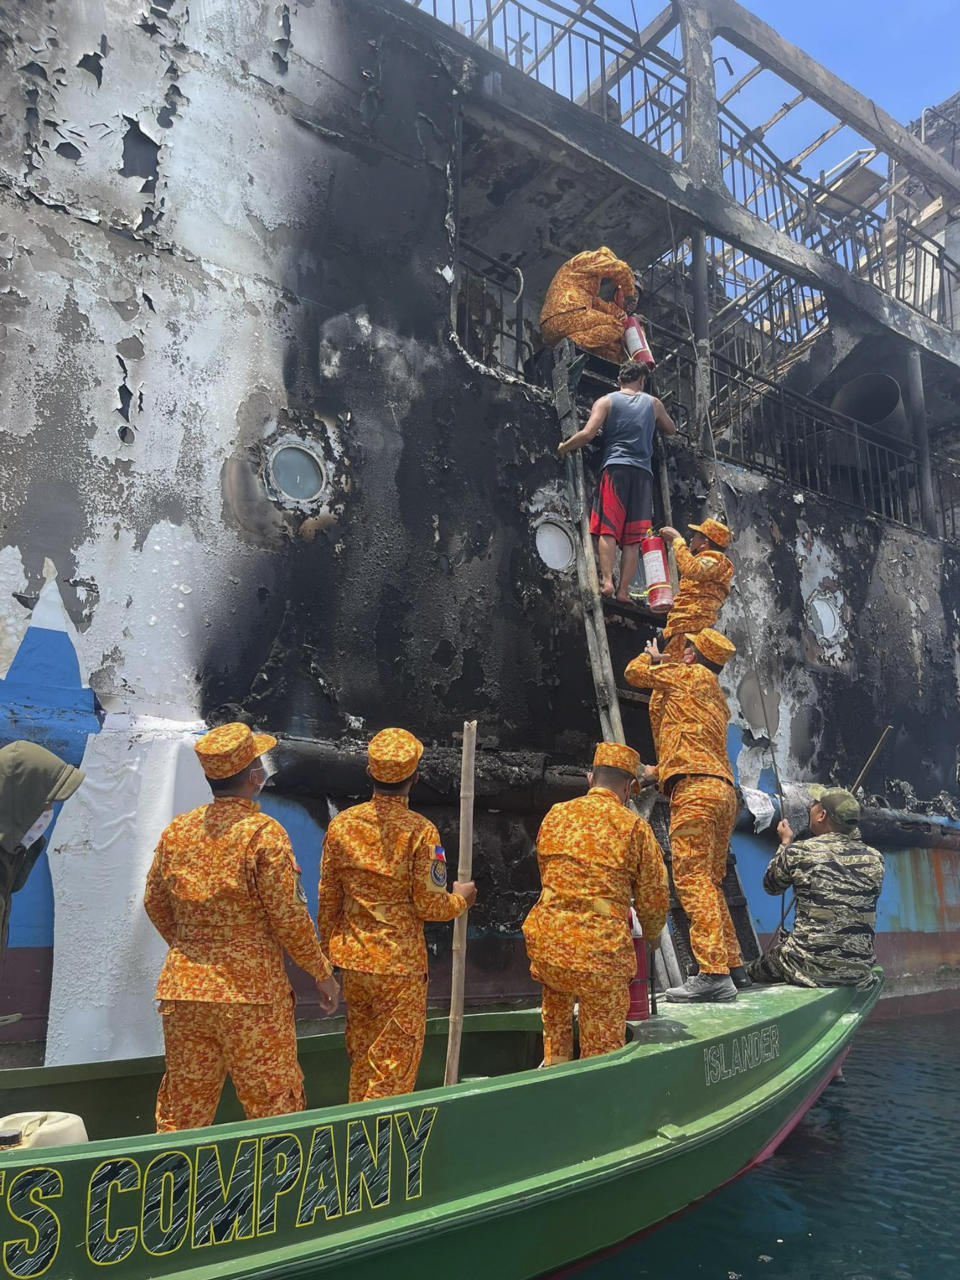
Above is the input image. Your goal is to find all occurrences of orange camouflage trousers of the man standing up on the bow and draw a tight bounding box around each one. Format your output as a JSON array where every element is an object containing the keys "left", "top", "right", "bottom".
[{"left": 669, "top": 777, "right": 742, "bottom": 973}]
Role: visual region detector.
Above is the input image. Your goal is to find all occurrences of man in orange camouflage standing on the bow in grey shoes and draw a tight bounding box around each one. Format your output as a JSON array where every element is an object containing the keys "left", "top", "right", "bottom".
[{"left": 626, "top": 627, "right": 750, "bottom": 1002}]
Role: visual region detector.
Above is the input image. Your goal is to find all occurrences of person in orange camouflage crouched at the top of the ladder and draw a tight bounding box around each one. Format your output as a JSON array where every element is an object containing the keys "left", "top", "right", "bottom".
[{"left": 540, "top": 247, "right": 636, "bottom": 365}]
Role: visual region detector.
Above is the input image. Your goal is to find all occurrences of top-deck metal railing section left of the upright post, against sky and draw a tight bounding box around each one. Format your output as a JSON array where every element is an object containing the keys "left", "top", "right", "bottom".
[{"left": 408, "top": 0, "right": 687, "bottom": 160}]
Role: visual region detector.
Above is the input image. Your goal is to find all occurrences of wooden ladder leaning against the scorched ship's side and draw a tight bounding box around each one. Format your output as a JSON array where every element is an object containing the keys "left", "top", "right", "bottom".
[{"left": 552, "top": 338, "right": 760, "bottom": 991}]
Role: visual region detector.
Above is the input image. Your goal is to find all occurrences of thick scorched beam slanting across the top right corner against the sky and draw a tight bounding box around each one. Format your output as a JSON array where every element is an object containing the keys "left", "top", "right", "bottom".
[{"left": 701, "top": 0, "right": 960, "bottom": 202}]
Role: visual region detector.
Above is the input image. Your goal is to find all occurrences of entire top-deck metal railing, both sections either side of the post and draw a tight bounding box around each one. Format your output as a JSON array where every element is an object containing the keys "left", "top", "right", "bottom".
[{"left": 407, "top": 0, "right": 960, "bottom": 329}]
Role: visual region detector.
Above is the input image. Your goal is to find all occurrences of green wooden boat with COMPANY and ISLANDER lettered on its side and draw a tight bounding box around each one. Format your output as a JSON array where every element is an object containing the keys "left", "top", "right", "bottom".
[{"left": 0, "top": 974, "right": 881, "bottom": 1280}]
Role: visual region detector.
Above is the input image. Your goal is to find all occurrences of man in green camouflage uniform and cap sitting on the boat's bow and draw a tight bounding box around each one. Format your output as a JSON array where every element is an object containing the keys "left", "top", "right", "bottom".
[{"left": 746, "top": 787, "right": 883, "bottom": 987}]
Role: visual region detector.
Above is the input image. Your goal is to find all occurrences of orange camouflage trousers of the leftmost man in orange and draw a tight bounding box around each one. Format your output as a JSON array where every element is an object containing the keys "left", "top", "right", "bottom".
[{"left": 156, "top": 998, "right": 306, "bottom": 1133}]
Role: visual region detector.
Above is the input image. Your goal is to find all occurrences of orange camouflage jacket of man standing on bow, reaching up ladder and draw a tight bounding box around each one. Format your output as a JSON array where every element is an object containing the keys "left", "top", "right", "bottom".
[{"left": 626, "top": 653, "right": 733, "bottom": 788}]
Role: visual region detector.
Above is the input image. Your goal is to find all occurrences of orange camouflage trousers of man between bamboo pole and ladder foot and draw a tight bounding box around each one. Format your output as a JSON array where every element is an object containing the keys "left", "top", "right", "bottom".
[{"left": 530, "top": 964, "right": 630, "bottom": 1066}]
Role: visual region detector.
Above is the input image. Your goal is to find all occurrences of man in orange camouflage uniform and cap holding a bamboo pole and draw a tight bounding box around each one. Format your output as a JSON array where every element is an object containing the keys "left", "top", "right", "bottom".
[{"left": 317, "top": 728, "right": 476, "bottom": 1102}]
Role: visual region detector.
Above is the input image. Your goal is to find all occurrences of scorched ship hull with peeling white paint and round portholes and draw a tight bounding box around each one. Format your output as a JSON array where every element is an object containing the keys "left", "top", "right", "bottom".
[{"left": 0, "top": 0, "right": 960, "bottom": 1062}]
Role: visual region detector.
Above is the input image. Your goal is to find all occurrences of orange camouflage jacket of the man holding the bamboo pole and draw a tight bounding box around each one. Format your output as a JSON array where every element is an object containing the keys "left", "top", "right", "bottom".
[{"left": 317, "top": 794, "right": 467, "bottom": 974}]
